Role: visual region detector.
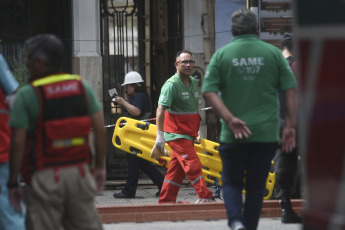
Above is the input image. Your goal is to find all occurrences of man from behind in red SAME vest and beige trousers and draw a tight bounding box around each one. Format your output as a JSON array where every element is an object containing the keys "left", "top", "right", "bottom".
[{"left": 7, "top": 34, "right": 106, "bottom": 229}]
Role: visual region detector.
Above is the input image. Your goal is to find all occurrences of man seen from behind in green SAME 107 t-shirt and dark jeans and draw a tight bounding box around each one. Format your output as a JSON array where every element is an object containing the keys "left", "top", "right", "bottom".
[{"left": 202, "top": 9, "right": 296, "bottom": 230}]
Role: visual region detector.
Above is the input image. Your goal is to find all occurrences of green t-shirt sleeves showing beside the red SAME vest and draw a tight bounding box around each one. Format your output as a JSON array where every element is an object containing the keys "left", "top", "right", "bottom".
[{"left": 9, "top": 81, "right": 102, "bottom": 132}]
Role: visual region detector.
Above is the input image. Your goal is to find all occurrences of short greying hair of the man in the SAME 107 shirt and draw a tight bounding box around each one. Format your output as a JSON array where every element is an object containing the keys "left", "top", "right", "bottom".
[{"left": 231, "top": 9, "right": 257, "bottom": 36}]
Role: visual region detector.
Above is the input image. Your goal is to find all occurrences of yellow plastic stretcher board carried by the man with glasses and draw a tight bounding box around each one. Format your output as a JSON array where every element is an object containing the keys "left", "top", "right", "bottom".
[{"left": 112, "top": 117, "right": 275, "bottom": 199}]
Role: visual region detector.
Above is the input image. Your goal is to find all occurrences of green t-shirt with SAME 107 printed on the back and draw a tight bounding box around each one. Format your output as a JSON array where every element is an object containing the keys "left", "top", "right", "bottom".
[{"left": 202, "top": 34, "right": 296, "bottom": 143}]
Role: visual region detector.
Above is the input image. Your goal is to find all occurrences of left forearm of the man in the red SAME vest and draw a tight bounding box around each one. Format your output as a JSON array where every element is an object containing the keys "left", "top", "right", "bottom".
[{"left": 9, "top": 128, "right": 26, "bottom": 183}]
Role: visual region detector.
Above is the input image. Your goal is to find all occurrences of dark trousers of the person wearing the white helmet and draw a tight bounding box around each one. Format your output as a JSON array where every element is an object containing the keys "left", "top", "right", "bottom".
[{"left": 122, "top": 154, "right": 164, "bottom": 196}]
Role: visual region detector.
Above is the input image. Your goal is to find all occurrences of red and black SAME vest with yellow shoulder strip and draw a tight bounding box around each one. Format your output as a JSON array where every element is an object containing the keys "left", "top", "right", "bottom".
[{"left": 23, "top": 74, "right": 92, "bottom": 181}]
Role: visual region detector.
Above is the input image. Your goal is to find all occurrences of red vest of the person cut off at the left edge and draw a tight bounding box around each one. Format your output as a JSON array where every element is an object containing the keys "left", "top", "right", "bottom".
[{"left": 0, "top": 89, "right": 11, "bottom": 163}]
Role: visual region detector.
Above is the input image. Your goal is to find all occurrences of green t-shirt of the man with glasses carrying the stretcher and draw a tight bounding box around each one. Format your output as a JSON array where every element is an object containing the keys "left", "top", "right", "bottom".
[{"left": 158, "top": 74, "right": 199, "bottom": 141}]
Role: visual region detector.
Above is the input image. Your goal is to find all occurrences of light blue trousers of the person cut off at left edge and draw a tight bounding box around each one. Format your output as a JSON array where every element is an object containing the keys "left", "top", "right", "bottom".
[{"left": 0, "top": 162, "right": 25, "bottom": 230}]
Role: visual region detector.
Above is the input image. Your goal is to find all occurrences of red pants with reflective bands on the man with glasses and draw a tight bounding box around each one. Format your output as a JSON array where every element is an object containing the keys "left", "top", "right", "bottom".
[{"left": 158, "top": 138, "right": 213, "bottom": 203}]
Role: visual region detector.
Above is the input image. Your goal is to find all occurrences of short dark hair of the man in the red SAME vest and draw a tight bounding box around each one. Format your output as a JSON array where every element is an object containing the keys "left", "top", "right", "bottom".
[{"left": 24, "top": 34, "right": 64, "bottom": 72}]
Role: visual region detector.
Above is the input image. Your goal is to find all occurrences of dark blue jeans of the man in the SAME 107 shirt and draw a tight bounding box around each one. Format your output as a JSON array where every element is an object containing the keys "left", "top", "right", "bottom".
[{"left": 218, "top": 143, "right": 277, "bottom": 230}]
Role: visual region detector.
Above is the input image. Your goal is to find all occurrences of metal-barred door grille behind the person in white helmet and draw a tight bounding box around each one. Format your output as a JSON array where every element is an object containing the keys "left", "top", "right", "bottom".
[{"left": 101, "top": 0, "right": 139, "bottom": 125}]
